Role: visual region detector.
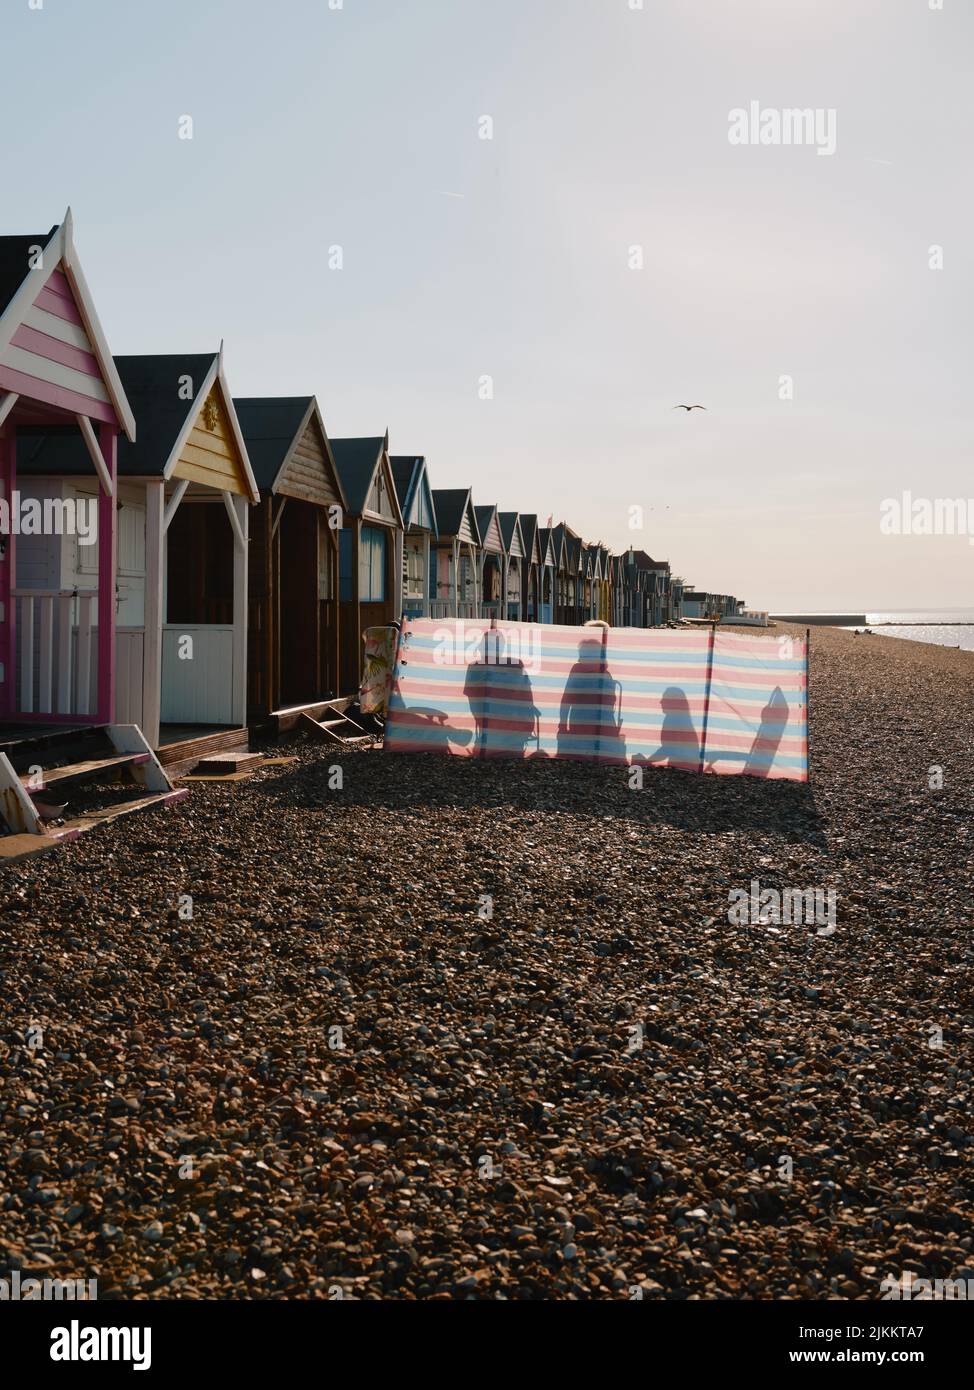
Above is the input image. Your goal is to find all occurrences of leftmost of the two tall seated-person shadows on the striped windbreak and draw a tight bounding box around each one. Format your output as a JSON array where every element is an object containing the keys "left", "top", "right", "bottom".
[{"left": 464, "top": 632, "right": 545, "bottom": 758}]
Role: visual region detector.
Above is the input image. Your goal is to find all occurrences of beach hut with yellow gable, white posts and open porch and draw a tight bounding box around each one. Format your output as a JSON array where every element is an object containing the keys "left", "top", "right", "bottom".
[{"left": 19, "top": 349, "right": 258, "bottom": 770}]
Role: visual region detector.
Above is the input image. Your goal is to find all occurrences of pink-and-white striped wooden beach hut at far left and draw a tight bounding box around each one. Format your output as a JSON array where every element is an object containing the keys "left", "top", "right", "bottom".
[{"left": 0, "top": 210, "right": 136, "bottom": 727}]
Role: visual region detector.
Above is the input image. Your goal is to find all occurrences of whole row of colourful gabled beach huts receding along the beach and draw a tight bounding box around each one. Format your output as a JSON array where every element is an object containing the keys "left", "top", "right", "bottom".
[{"left": 0, "top": 213, "right": 736, "bottom": 767}]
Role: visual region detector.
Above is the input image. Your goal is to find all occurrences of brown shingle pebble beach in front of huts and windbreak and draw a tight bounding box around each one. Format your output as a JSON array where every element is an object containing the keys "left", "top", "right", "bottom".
[{"left": 0, "top": 626, "right": 974, "bottom": 1300}]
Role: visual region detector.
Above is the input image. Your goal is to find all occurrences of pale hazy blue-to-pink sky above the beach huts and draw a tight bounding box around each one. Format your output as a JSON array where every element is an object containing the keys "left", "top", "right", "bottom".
[{"left": 0, "top": 0, "right": 974, "bottom": 612}]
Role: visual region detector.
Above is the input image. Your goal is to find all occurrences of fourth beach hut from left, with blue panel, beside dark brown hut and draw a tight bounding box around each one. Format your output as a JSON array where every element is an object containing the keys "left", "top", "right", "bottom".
[{"left": 331, "top": 432, "right": 403, "bottom": 695}]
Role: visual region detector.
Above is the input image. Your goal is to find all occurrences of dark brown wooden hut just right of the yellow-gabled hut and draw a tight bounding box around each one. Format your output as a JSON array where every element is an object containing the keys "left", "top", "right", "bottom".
[{"left": 233, "top": 396, "right": 346, "bottom": 728}]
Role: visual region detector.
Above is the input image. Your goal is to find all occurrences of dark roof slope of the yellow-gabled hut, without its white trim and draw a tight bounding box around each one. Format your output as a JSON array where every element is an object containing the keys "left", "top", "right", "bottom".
[{"left": 17, "top": 353, "right": 217, "bottom": 478}]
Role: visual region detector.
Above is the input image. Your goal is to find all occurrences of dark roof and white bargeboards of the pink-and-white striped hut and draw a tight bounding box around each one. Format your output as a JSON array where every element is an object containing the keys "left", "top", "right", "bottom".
[{"left": 0, "top": 209, "right": 135, "bottom": 441}]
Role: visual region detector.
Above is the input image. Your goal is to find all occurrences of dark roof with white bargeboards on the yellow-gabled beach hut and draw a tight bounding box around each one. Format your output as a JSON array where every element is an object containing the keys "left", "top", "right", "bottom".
[{"left": 17, "top": 350, "right": 260, "bottom": 502}]
